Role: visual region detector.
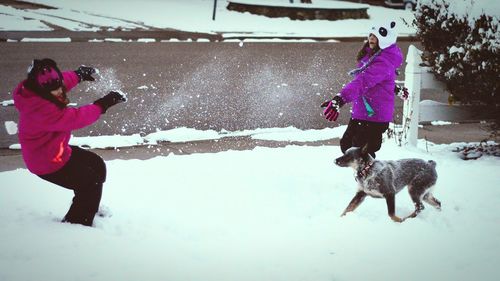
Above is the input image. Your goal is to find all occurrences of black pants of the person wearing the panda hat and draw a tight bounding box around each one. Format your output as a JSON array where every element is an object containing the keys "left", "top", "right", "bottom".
[{"left": 340, "top": 118, "right": 389, "bottom": 158}]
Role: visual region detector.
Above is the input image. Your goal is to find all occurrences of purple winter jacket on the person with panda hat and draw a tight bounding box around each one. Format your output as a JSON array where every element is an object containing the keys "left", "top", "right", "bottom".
[{"left": 340, "top": 44, "right": 403, "bottom": 122}]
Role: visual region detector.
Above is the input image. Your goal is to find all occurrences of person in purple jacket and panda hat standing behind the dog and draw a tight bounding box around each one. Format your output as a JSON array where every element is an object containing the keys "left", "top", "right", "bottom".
[{"left": 321, "top": 21, "right": 403, "bottom": 158}]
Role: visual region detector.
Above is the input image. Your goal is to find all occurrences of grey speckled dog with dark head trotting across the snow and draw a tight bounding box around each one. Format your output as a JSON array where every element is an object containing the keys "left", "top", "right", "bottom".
[{"left": 335, "top": 145, "right": 441, "bottom": 222}]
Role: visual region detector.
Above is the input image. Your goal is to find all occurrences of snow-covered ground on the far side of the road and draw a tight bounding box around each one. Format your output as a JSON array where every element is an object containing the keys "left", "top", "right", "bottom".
[{"left": 0, "top": 0, "right": 415, "bottom": 37}]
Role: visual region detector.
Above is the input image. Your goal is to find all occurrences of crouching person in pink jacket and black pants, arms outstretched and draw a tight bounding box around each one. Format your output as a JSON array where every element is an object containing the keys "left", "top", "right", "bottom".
[{"left": 13, "top": 59, "right": 126, "bottom": 226}]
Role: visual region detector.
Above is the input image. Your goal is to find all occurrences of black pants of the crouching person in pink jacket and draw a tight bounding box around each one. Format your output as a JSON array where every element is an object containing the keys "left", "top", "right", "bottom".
[{"left": 39, "top": 146, "right": 106, "bottom": 226}]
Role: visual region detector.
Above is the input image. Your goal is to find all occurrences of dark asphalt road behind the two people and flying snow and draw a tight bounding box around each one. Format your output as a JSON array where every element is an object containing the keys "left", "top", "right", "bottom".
[{"left": 0, "top": 41, "right": 418, "bottom": 148}]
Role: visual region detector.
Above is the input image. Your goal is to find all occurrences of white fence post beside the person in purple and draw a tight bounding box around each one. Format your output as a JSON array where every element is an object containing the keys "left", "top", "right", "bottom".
[{"left": 403, "top": 45, "right": 422, "bottom": 146}]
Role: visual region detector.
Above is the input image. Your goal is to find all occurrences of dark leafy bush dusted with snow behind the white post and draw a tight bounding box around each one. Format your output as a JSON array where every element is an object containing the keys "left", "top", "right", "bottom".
[{"left": 415, "top": 0, "right": 500, "bottom": 132}]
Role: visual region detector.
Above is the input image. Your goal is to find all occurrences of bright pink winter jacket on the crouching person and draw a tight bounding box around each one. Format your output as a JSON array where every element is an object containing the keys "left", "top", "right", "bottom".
[{"left": 13, "top": 71, "right": 101, "bottom": 175}]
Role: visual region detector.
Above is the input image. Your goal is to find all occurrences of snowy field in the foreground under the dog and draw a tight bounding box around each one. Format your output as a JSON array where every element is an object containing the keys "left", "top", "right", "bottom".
[{"left": 0, "top": 140, "right": 500, "bottom": 281}]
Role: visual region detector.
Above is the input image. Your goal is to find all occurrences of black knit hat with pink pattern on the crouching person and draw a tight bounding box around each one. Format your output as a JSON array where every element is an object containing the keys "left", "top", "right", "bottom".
[{"left": 27, "top": 59, "right": 63, "bottom": 92}]
